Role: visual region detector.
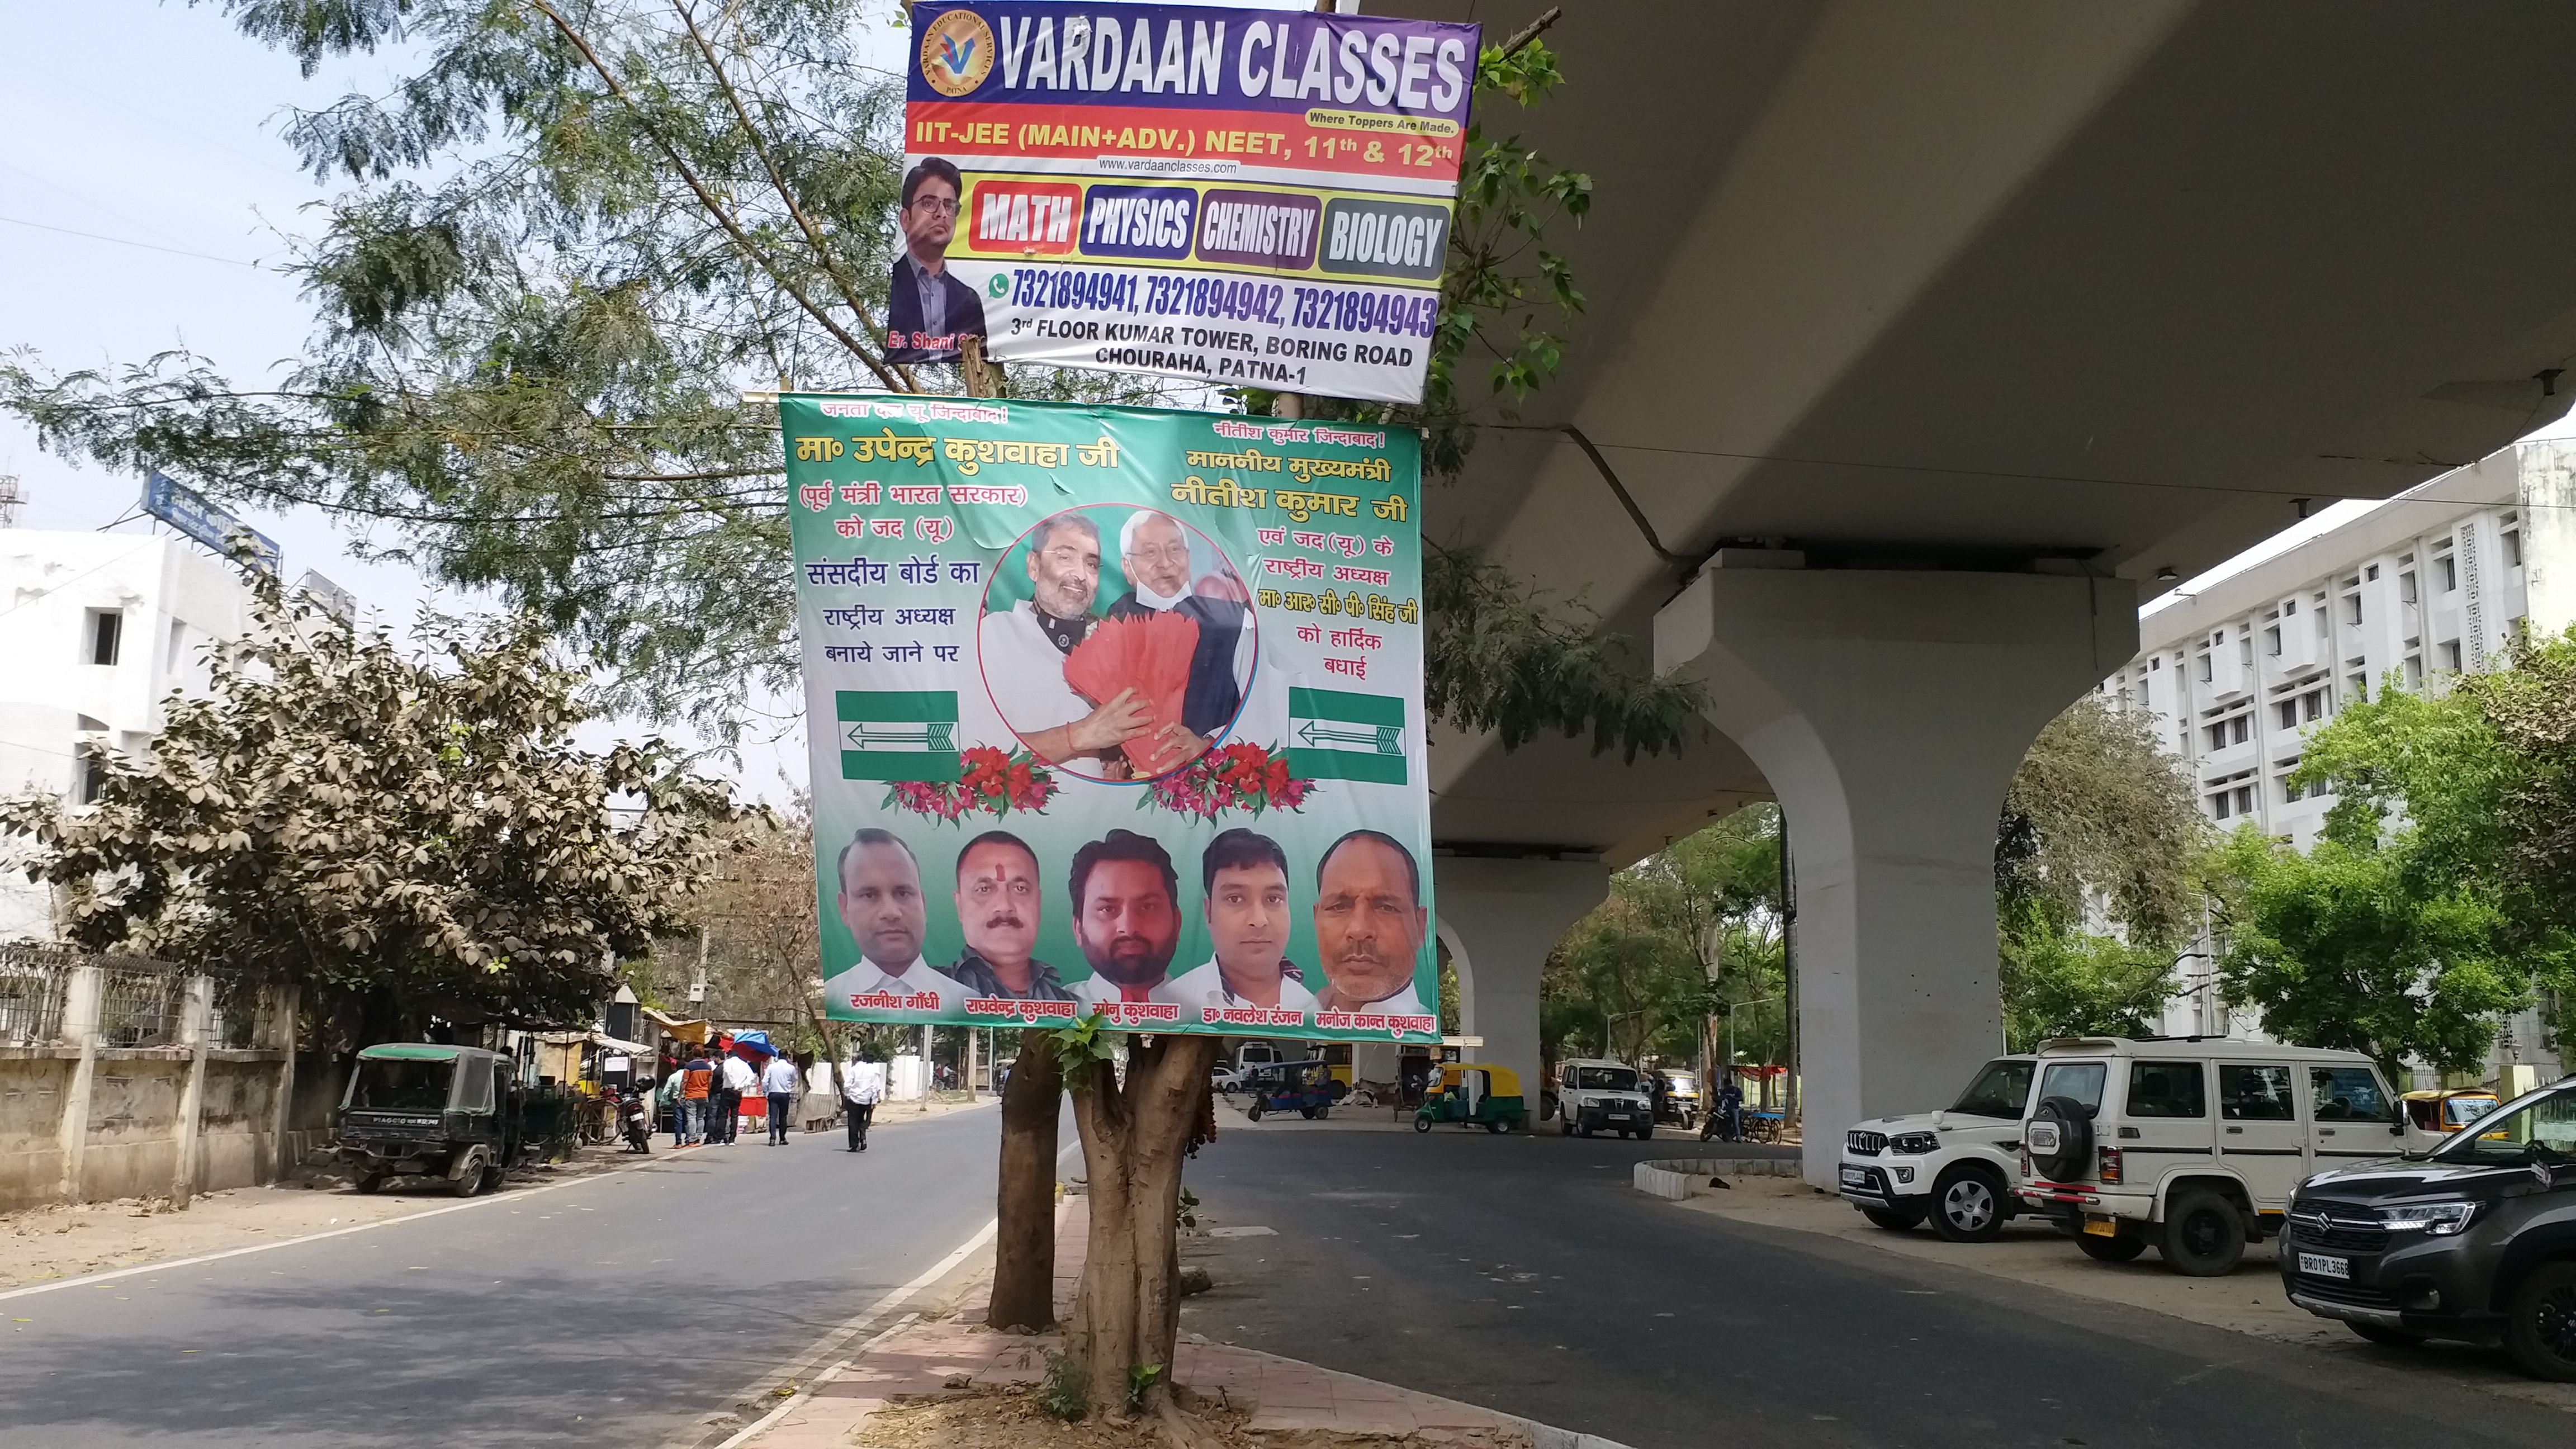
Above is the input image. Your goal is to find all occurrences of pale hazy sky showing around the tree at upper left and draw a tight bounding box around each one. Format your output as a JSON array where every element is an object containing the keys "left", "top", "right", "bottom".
[{"left": 0, "top": 0, "right": 1308, "bottom": 804}]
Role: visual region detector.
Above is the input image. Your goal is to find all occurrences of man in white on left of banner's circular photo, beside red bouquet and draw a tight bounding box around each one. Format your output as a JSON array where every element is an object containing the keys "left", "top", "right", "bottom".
[{"left": 976, "top": 513, "right": 1180, "bottom": 779}]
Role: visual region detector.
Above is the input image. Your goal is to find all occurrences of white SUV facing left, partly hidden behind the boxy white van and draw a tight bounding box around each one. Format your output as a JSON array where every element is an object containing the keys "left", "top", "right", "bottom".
[{"left": 1842, "top": 1057, "right": 2033, "bottom": 1243}]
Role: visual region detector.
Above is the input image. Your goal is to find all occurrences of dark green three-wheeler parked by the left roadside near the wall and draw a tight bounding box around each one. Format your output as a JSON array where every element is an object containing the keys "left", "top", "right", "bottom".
[{"left": 332, "top": 1041, "right": 523, "bottom": 1196}]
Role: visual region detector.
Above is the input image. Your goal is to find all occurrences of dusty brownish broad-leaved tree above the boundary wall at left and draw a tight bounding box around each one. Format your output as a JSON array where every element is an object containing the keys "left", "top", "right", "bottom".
[{"left": 0, "top": 575, "right": 742, "bottom": 1047}]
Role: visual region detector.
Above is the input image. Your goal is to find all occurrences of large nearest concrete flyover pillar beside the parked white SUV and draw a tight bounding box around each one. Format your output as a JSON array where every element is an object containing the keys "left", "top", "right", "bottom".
[{"left": 1654, "top": 567, "right": 2138, "bottom": 1186}]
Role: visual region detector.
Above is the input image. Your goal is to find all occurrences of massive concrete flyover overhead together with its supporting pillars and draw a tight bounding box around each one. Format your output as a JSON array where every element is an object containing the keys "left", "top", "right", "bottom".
[{"left": 1401, "top": 0, "right": 2576, "bottom": 1181}]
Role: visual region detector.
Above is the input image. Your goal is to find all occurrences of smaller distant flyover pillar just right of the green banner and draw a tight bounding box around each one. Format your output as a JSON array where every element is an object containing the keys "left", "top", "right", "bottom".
[{"left": 1432, "top": 856, "right": 1610, "bottom": 1126}]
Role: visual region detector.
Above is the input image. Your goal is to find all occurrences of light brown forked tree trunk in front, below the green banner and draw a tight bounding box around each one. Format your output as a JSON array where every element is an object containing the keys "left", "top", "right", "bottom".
[{"left": 1064, "top": 1034, "right": 1219, "bottom": 1413}]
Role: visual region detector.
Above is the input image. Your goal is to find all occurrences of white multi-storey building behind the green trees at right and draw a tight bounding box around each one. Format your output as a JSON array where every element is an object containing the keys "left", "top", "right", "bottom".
[{"left": 2102, "top": 441, "right": 2576, "bottom": 1067}]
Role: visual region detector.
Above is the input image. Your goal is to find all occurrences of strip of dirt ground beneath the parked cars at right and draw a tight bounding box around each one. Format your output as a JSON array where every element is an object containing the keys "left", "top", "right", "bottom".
[{"left": 1674, "top": 1178, "right": 2576, "bottom": 1410}]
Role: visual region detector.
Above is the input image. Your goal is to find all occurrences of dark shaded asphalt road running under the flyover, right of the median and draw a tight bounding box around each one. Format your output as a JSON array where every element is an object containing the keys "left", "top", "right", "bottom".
[{"left": 1182, "top": 1124, "right": 2576, "bottom": 1449}]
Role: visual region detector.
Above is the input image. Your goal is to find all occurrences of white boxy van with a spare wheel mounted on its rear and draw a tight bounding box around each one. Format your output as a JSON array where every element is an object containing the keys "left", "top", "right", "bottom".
[{"left": 2014, "top": 1036, "right": 2406, "bottom": 1276}]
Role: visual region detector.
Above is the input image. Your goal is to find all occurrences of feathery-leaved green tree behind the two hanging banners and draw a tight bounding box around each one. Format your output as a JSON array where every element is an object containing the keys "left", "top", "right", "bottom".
[{"left": 0, "top": 0, "right": 1649, "bottom": 1402}]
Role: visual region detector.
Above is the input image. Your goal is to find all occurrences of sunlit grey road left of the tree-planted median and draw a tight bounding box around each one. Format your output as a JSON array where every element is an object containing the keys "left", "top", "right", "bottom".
[{"left": 0, "top": 1109, "right": 997, "bottom": 1449}]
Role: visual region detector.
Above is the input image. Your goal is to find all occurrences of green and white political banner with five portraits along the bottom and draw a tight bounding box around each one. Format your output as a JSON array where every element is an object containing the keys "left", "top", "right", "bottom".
[{"left": 778, "top": 395, "right": 1437, "bottom": 1041}]
